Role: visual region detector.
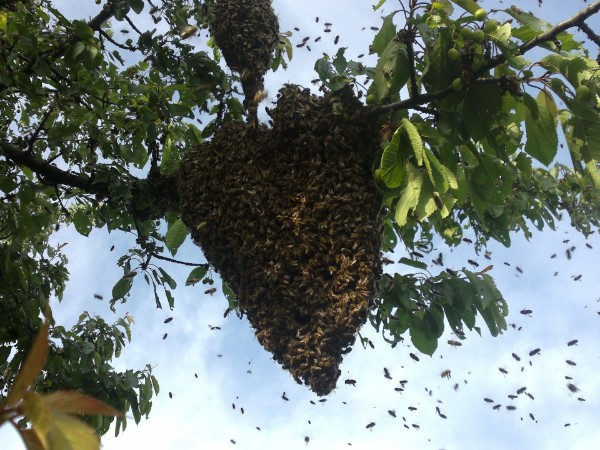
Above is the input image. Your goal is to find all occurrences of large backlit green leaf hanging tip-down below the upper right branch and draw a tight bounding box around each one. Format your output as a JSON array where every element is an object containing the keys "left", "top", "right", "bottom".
[{"left": 523, "top": 90, "right": 558, "bottom": 165}]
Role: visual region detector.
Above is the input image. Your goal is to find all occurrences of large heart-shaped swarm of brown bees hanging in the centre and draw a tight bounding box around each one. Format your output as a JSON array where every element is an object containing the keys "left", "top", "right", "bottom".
[{"left": 179, "top": 85, "right": 382, "bottom": 395}]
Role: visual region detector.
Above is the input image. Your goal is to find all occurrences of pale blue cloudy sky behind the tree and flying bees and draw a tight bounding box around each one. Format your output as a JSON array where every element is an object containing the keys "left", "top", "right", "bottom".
[{"left": 0, "top": 0, "right": 600, "bottom": 450}]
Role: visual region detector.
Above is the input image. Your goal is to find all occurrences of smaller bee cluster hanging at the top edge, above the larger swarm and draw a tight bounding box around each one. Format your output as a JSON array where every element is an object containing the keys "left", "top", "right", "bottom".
[{"left": 212, "top": 0, "right": 279, "bottom": 114}]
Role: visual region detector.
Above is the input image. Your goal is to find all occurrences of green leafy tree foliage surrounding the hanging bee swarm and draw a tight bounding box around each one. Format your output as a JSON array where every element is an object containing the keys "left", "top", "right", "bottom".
[{"left": 0, "top": 0, "right": 600, "bottom": 442}]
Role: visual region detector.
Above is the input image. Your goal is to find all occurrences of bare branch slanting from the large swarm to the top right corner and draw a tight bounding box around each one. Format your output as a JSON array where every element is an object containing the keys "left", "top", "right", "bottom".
[{"left": 368, "top": 1, "right": 600, "bottom": 115}]
